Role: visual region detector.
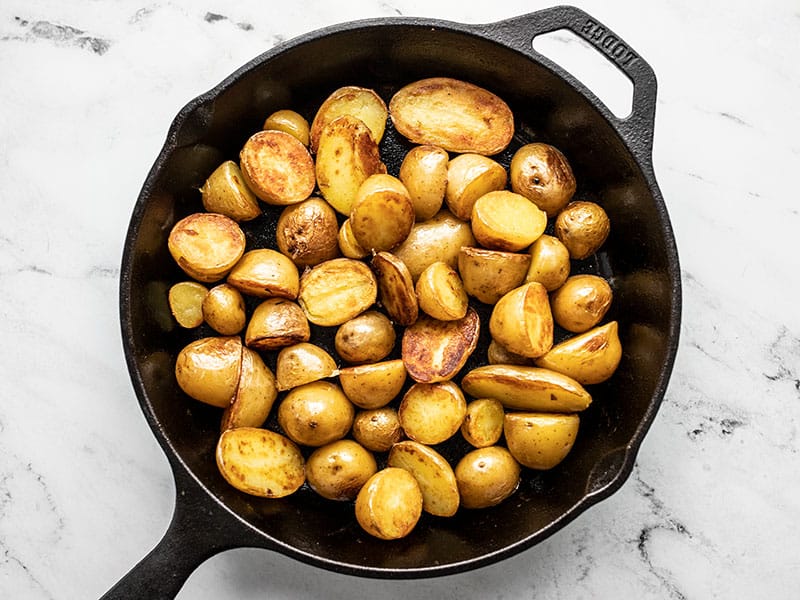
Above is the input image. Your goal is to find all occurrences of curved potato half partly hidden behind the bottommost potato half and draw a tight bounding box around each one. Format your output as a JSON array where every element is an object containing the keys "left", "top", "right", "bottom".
[{"left": 386, "top": 440, "right": 461, "bottom": 517}]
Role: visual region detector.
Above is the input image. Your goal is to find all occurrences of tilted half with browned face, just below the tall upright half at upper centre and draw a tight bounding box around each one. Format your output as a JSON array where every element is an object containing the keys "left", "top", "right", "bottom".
[{"left": 350, "top": 173, "right": 414, "bottom": 252}]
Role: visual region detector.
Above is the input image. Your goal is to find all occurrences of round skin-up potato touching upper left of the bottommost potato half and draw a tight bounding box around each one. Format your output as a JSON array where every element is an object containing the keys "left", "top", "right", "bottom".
[{"left": 306, "top": 440, "right": 378, "bottom": 500}]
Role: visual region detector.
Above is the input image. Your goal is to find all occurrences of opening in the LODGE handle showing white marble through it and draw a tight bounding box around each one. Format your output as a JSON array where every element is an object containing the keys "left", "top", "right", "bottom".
[{"left": 533, "top": 29, "right": 633, "bottom": 119}]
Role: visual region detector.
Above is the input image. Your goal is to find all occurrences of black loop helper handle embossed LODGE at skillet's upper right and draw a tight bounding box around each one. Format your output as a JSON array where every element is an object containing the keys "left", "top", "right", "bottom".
[{"left": 490, "top": 6, "right": 657, "bottom": 164}]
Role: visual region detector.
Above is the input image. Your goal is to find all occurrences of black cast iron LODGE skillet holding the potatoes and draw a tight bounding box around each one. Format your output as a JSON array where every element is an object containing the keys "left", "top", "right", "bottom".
[{"left": 104, "top": 6, "right": 681, "bottom": 598}]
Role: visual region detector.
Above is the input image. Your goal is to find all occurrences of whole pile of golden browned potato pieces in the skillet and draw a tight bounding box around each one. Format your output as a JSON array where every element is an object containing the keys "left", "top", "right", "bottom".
[{"left": 168, "top": 78, "right": 622, "bottom": 539}]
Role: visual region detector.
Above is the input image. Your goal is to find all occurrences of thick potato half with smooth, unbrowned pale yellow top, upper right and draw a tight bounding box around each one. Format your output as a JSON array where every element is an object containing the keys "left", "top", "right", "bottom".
[{"left": 471, "top": 190, "right": 547, "bottom": 252}]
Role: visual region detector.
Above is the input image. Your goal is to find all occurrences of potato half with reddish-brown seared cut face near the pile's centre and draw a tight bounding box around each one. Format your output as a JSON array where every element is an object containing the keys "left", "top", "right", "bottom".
[{"left": 401, "top": 307, "right": 480, "bottom": 383}]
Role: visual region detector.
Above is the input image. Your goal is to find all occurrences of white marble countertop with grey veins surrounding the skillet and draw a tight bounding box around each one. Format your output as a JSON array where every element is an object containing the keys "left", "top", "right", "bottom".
[{"left": 0, "top": 0, "right": 800, "bottom": 600}]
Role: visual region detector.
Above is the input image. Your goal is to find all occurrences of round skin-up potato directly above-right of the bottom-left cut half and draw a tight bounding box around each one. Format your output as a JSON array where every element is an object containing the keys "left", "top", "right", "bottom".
[{"left": 278, "top": 381, "right": 355, "bottom": 447}]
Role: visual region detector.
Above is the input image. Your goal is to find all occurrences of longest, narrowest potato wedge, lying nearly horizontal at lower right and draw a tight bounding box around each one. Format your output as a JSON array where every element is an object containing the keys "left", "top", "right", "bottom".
[{"left": 461, "top": 365, "right": 592, "bottom": 413}]
